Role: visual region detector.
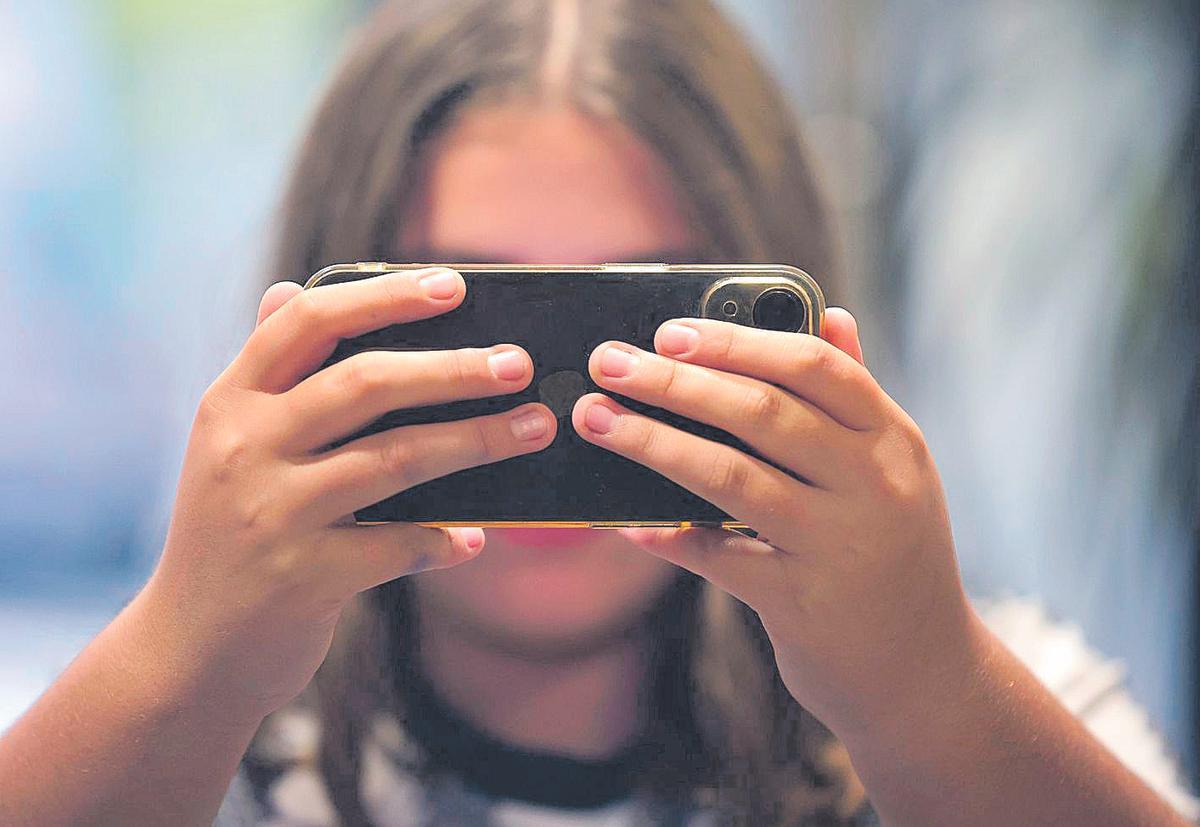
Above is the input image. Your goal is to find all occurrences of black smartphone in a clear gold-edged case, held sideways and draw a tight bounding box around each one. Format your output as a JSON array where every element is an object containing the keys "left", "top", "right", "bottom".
[{"left": 305, "top": 262, "right": 826, "bottom": 529}]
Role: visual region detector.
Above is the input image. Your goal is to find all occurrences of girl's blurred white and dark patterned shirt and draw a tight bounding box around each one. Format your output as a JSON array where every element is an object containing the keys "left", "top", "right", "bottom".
[{"left": 214, "top": 599, "right": 1200, "bottom": 827}]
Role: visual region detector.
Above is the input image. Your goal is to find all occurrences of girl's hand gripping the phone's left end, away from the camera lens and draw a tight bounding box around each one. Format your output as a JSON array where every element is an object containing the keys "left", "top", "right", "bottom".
[{"left": 139, "top": 269, "right": 557, "bottom": 720}]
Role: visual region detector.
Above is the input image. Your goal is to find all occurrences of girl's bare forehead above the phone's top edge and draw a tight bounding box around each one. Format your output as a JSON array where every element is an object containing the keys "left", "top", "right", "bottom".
[{"left": 398, "top": 106, "right": 697, "bottom": 264}]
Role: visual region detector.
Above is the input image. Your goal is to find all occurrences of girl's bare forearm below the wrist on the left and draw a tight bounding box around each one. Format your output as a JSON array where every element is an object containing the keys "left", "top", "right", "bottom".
[{"left": 0, "top": 573, "right": 258, "bottom": 827}]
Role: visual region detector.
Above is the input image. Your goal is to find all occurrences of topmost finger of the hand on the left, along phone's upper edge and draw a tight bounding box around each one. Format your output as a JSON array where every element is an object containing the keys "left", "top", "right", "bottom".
[{"left": 230, "top": 268, "right": 466, "bottom": 394}]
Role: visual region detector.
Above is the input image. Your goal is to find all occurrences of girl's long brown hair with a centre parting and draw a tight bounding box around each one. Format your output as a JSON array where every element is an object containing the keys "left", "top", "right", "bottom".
[{"left": 247, "top": 0, "right": 862, "bottom": 825}]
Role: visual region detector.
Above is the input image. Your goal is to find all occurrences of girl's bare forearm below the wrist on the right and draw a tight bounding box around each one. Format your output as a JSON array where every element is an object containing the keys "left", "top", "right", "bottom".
[{"left": 844, "top": 612, "right": 1186, "bottom": 827}]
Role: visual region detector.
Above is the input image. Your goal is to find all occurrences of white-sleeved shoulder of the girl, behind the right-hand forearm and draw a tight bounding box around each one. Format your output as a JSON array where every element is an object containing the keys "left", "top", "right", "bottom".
[{"left": 973, "top": 598, "right": 1200, "bottom": 820}]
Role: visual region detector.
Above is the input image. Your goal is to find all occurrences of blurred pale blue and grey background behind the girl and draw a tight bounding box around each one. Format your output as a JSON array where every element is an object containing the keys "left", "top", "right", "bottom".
[{"left": 0, "top": 0, "right": 1200, "bottom": 786}]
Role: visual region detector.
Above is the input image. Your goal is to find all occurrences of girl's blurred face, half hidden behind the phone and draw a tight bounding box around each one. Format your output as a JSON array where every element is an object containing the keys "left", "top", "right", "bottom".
[{"left": 400, "top": 106, "right": 698, "bottom": 657}]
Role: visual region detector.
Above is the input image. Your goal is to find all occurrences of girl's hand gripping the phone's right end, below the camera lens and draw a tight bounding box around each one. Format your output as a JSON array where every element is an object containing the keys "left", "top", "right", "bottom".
[{"left": 572, "top": 307, "right": 978, "bottom": 736}]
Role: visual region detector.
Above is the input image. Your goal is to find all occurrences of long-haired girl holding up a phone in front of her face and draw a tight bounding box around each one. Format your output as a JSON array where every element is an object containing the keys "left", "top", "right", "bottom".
[{"left": 0, "top": 0, "right": 1190, "bottom": 826}]
